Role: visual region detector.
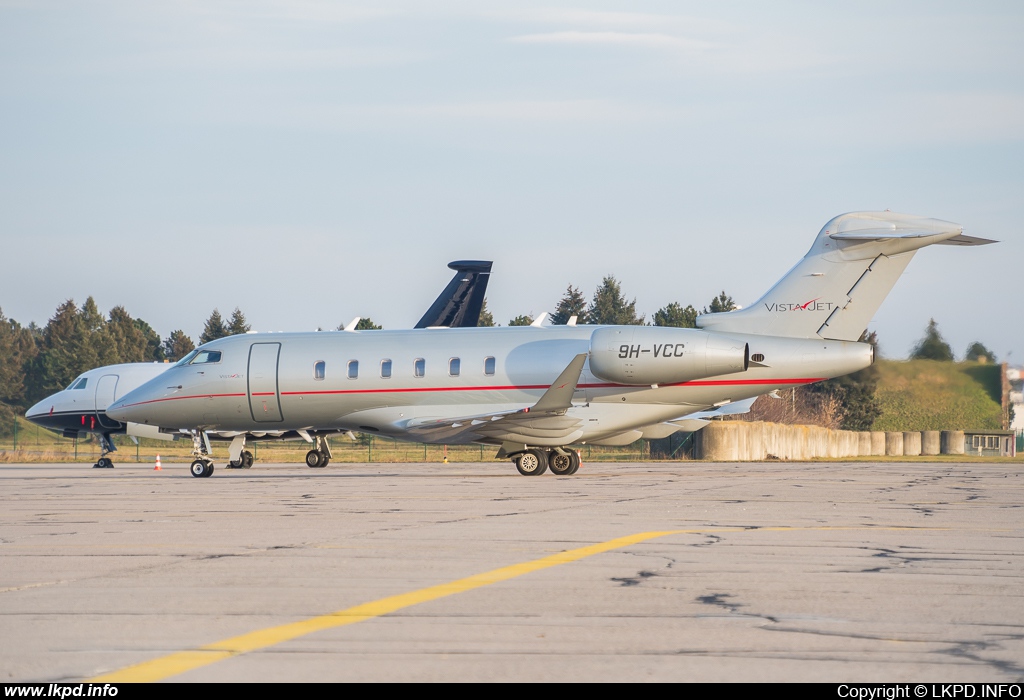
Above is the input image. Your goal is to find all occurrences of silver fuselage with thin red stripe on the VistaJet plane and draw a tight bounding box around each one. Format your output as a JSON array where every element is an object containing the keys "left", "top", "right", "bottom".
[{"left": 111, "top": 325, "right": 872, "bottom": 446}]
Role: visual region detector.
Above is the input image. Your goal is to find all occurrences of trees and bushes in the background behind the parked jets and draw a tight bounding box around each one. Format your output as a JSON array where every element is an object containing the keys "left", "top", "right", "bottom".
[{"left": 0, "top": 284, "right": 995, "bottom": 430}]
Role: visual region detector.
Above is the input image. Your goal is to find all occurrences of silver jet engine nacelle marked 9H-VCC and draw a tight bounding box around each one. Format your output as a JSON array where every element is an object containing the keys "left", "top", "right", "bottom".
[{"left": 590, "top": 325, "right": 750, "bottom": 385}]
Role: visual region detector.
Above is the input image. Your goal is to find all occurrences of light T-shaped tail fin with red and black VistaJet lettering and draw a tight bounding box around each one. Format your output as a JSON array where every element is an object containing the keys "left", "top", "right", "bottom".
[{"left": 696, "top": 212, "right": 995, "bottom": 341}]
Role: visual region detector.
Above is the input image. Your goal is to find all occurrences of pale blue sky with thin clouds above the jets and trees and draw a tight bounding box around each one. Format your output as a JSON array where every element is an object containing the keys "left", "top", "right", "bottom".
[{"left": 0, "top": 0, "right": 1024, "bottom": 364}]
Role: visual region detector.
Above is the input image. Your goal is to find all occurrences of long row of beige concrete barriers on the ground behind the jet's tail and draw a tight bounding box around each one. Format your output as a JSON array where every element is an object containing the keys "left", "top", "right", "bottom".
[{"left": 693, "top": 421, "right": 964, "bottom": 462}]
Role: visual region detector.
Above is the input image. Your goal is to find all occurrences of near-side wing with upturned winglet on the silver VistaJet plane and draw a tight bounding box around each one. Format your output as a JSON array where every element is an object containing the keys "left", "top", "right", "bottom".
[{"left": 404, "top": 353, "right": 587, "bottom": 445}]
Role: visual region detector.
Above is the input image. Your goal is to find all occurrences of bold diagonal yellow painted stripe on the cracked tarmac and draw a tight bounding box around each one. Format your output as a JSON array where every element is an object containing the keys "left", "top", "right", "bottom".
[{"left": 88, "top": 530, "right": 688, "bottom": 683}]
